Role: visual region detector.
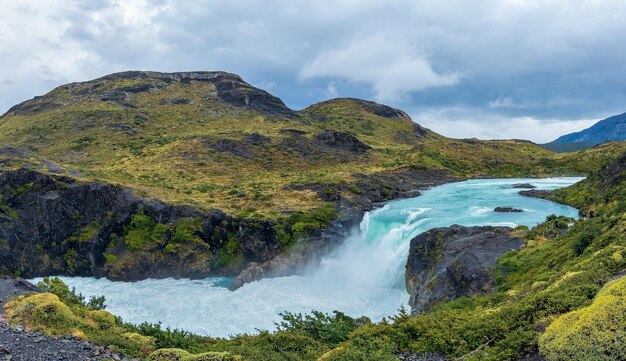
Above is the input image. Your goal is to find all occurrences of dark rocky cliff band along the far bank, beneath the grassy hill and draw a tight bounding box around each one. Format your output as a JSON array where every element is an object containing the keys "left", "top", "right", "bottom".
[{"left": 0, "top": 169, "right": 454, "bottom": 287}]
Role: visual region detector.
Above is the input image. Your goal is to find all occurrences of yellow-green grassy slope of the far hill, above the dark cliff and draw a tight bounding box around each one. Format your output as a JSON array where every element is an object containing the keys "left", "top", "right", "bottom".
[{"left": 0, "top": 72, "right": 623, "bottom": 217}]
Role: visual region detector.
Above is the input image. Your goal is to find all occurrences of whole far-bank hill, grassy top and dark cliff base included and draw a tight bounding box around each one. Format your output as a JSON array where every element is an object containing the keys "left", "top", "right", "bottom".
[{"left": 0, "top": 71, "right": 623, "bottom": 285}]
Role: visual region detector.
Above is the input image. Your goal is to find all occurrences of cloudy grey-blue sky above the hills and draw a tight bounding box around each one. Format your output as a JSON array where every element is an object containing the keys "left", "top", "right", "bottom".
[{"left": 0, "top": 0, "right": 626, "bottom": 142}]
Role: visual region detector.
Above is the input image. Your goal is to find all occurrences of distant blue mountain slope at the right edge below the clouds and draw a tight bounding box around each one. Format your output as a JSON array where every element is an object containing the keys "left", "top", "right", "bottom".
[{"left": 543, "top": 113, "right": 626, "bottom": 152}]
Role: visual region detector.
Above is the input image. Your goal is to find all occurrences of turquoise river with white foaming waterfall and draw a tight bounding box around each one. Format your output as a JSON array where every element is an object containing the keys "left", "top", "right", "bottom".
[{"left": 37, "top": 178, "right": 581, "bottom": 337}]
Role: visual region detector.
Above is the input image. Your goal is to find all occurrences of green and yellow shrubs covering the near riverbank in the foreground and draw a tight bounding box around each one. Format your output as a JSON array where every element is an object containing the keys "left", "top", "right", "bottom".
[{"left": 7, "top": 153, "right": 626, "bottom": 361}]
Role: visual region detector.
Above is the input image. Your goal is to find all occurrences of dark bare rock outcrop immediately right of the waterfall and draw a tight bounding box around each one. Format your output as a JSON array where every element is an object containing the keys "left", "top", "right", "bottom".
[{"left": 405, "top": 225, "right": 523, "bottom": 313}]
